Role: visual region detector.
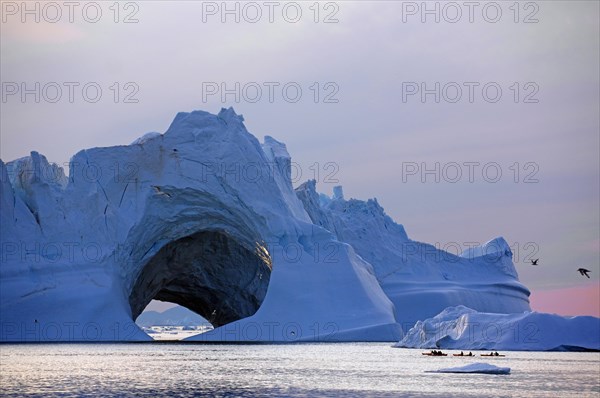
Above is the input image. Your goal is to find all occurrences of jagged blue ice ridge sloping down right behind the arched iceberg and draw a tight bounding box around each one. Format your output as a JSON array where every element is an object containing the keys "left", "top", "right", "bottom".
[{"left": 296, "top": 181, "right": 530, "bottom": 331}]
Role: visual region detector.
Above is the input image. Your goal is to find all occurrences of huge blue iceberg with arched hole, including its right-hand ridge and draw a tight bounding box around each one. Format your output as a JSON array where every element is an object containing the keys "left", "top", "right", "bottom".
[{"left": 0, "top": 108, "right": 529, "bottom": 341}]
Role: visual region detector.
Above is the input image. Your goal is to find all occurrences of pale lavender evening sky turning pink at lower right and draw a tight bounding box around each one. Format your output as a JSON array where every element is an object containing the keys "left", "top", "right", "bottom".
[{"left": 0, "top": 1, "right": 600, "bottom": 316}]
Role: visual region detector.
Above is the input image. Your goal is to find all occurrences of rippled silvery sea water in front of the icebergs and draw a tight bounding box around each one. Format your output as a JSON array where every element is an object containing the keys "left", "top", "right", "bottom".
[{"left": 0, "top": 343, "right": 600, "bottom": 397}]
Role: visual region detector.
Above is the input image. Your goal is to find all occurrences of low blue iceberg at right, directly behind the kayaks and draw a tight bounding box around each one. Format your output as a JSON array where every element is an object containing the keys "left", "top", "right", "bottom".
[{"left": 395, "top": 306, "right": 600, "bottom": 351}]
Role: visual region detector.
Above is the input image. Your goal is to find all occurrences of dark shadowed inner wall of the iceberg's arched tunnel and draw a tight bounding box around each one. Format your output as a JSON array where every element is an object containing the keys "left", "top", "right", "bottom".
[{"left": 129, "top": 230, "right": 271, "bottom": 327}]
